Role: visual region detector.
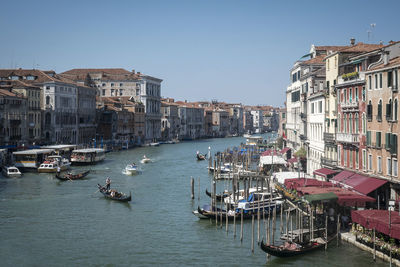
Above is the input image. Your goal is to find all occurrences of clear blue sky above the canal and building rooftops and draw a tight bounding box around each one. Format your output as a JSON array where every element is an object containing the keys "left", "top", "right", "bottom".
[{"left": 0, "top": 0, "right": 400, "bottom": 106}]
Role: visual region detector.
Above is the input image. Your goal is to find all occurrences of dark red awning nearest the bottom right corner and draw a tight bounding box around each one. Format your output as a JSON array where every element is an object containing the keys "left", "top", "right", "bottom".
[{"left": 351, "top": 210, "right": 400, "bottom": 242}]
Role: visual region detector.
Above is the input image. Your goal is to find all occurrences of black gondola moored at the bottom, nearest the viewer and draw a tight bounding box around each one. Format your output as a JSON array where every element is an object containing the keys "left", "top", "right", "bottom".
[{"left": 260, "top": 237, "right": 334, "bottom": 258}]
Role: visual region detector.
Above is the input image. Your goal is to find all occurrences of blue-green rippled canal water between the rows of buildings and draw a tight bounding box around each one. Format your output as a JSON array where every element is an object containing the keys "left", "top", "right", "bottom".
[{"left": 0, "top": 137, "right": 388, "bottom": 266}]
